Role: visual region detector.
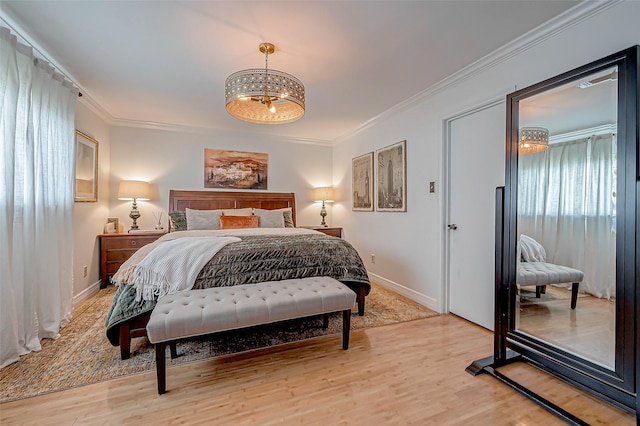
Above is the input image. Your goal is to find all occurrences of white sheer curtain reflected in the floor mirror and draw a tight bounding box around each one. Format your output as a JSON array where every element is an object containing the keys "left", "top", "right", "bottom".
[{"left": 518, "top": 134, "right": 616, "bottom": 299}]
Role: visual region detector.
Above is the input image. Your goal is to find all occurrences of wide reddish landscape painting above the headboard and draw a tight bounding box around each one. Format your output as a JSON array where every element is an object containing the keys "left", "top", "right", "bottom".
[{"left": 204, "top": 148, "right": 269, "bottom": 189}]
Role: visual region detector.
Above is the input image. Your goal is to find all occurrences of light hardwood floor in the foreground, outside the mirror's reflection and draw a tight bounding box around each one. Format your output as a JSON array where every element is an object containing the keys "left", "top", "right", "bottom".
[{"left": 0, "top": 315, "right": 635, "bottom": 425}]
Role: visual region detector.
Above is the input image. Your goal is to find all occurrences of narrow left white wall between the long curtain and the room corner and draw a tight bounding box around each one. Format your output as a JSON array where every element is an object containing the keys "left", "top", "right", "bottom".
[{"left": 73, "top": 100, "right": 110, "bottom": 302}]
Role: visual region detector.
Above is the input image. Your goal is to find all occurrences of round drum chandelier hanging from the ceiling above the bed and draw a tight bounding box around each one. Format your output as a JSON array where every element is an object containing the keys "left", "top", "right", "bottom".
[{"left": 225, "top": 43, "right": 304, "bottom": 124}]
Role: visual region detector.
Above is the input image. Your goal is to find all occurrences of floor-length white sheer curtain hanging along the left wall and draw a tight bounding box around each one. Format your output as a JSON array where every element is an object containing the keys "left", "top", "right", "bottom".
[{"left": 0, "top": 27, "right": 78, "bottom": 368}]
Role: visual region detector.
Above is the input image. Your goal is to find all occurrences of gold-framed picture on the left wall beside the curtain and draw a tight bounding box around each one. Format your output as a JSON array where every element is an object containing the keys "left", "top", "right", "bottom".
[{"left": 75, "top": 130, "right": 98, "bottom": 202}]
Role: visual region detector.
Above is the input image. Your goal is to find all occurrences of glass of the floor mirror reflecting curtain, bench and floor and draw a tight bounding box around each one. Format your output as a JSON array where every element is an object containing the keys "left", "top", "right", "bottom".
[{"left": 516, "top": 68, "right": 617, "bottom": 369}]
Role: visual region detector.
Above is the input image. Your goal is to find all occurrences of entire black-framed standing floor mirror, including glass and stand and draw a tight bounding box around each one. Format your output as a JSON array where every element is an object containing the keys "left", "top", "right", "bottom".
[{"left": 468, "top": 46, "right": 640, "bottom": 424}]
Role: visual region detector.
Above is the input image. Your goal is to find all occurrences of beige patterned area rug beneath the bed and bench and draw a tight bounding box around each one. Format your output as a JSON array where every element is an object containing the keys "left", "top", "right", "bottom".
[{"left": 0, "top": 284, "right": 438, "bottom": 403}]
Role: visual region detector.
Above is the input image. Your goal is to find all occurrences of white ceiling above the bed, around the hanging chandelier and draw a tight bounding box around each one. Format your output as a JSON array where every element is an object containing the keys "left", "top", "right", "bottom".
[{"left": 0, "top": 0, "right": 578, "bottom": 142}]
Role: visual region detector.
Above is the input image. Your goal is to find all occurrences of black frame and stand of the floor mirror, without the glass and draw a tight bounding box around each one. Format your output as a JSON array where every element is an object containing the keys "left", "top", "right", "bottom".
[{"left": 467, "top": 46, "right": 640, "bottom": 424}]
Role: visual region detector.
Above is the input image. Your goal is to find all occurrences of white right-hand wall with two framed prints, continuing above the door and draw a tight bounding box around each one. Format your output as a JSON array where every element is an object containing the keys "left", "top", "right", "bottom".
[{"left": 333, "top": 1, "right": 640, "bottom": 310}]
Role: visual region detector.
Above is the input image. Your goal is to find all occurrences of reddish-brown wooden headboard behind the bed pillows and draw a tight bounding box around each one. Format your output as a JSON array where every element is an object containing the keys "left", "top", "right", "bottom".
[{"left": 169, "top": 189, "right": 296, "bottom": 225}]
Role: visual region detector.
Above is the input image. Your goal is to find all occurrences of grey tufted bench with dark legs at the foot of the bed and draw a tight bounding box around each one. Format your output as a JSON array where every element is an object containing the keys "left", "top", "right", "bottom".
[{"left": 147, "top": 277, "right": 356, "bottom": 394}]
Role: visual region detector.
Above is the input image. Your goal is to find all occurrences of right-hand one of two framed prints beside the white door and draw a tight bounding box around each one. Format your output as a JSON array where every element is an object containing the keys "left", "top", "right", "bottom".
[{"left": 375, "top": 140, "right": 407, "bottom": 212}]
